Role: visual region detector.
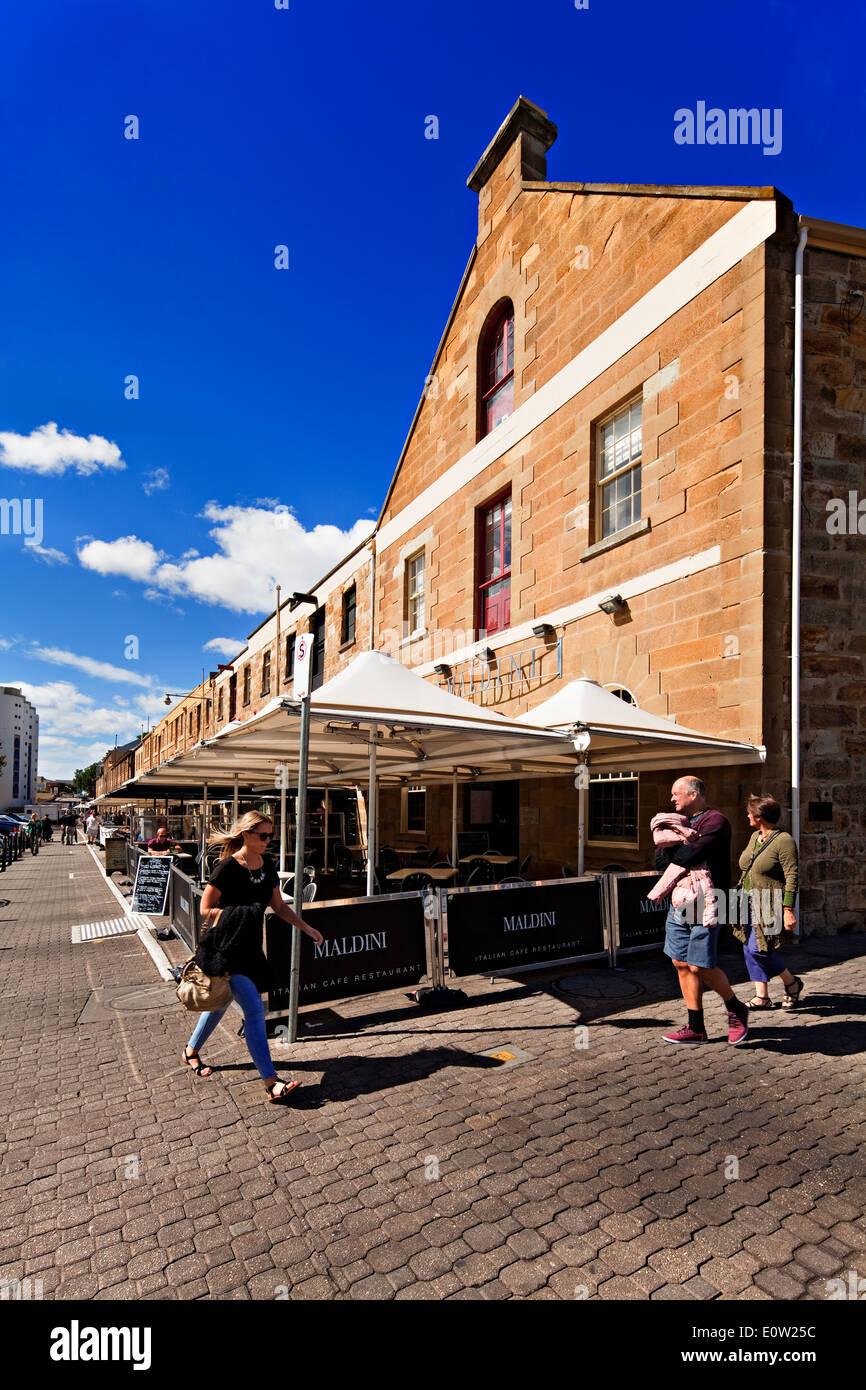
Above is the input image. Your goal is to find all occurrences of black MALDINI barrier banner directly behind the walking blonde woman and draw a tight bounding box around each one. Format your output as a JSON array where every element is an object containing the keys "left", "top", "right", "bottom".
[{"left": 265, "top": 894, "right": 427, "bottom": 1009}]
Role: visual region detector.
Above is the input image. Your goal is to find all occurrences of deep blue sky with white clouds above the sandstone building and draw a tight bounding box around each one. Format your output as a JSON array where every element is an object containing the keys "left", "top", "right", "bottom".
[{"left": 0, "top": 0, "right": 866, "bottom": 777}]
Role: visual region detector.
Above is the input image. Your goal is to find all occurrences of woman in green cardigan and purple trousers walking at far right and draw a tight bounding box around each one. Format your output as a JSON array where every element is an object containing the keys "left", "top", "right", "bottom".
[{"left": 734, "top": 796, "right": 803, "bottom": 1009}]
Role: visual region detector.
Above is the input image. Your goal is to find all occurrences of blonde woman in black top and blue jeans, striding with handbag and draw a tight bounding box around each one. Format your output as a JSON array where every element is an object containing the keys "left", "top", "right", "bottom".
[{"left": 183, "top": 810, "right": 324, "bottom": 1104}]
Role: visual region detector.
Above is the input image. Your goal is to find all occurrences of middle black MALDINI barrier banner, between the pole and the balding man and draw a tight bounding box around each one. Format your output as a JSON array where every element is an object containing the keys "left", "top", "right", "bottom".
[{"left": 448, "top": 878, "right": 605, "bottom": 974}]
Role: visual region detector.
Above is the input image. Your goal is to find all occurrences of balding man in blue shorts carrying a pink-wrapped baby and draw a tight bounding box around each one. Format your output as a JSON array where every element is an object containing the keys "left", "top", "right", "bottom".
[{"left": 656, "top": 777, "right": 749, "bottom": 1047}]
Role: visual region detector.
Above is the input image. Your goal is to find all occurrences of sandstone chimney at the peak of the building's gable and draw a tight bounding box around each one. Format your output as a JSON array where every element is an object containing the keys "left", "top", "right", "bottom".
[{"left": 466, "top": 96, "right": 557, "bottom": 240}]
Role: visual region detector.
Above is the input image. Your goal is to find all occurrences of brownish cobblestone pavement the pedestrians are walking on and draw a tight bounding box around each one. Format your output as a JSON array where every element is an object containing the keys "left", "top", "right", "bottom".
[{"left": 0, "top": 844, "right": 866, "bottom": 1300}]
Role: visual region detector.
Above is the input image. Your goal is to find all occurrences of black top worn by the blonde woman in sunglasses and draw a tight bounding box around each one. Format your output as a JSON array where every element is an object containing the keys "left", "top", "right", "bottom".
[{"left": 196, "top": 855, "right": 279, "bottom": 994}]
